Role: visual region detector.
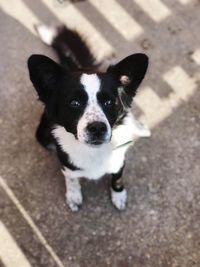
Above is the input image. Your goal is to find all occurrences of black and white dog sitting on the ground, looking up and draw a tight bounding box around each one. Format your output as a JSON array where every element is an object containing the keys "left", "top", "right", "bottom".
[{"left": 28, "top": 25, "right": 150, "bottom": 211}]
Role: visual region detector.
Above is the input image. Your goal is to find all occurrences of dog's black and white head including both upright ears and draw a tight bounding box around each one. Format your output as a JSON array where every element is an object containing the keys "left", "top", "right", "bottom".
[{"left": 28, "top": 54, "right": 148, "bottom": 145}]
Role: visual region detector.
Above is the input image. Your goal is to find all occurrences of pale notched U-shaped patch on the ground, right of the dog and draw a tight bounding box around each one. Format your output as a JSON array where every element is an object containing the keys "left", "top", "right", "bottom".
[{"left": 135, "top": 66, "right": 197, "bottom": 128}]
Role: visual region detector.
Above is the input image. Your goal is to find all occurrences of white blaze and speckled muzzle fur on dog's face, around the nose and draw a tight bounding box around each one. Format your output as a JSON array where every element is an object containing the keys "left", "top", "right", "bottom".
[{"left": 77, "top": 74, "right": 111, "bottom": 142}]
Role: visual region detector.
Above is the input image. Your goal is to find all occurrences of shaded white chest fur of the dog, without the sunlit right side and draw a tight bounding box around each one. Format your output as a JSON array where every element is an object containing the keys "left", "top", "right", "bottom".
[{"left": 52, "top": 126, "right": 112, "bottom": 180}]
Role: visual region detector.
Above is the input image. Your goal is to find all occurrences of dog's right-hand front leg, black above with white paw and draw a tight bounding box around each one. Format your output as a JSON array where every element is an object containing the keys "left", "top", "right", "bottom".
[{"left": 111, "top": 166, "right": 127, "bottom": 210}]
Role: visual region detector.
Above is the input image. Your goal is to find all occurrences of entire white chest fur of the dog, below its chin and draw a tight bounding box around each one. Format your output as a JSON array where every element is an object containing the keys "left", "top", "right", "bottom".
[{"left": 53, "top": 112, "right": 134, "bottom": 180}]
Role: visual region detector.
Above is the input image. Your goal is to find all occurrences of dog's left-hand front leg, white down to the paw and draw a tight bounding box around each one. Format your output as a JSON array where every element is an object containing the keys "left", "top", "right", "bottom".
[{"left": 64, "top": 174, "right": 83, "bottom": 214}]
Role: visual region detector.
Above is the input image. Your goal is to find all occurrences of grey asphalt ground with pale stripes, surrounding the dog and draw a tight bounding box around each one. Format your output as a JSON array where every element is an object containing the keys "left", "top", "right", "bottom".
[{"left": 0, "top": 0, "right": 200, "bottom": 267}]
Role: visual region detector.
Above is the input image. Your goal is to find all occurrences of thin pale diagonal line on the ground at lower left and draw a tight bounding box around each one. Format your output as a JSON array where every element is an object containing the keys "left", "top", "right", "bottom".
[{"left": 0, "top": 176, "right": 64, "bottom": 267}]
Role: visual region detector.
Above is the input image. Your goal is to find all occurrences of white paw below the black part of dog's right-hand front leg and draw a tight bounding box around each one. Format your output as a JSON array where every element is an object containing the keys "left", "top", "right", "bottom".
[{"left": 111, "top": 189, "right": 127, "bottom": 210}]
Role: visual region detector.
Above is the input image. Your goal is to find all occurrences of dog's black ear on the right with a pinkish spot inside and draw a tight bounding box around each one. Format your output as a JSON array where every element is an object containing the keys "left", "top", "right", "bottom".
[{"left": 107, "top": 54, "right": 148, "bottom": 98}]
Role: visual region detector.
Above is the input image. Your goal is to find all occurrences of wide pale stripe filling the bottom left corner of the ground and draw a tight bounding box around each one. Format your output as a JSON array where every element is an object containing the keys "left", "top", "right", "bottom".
[{"left": 0, "top": 221, "right": 31, "bottom": 267}]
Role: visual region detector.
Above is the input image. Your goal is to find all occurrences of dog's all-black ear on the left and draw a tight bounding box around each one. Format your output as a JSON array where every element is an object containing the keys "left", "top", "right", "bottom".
[{"left": 28, "top": 55, "right": 67, "bottom": 104}]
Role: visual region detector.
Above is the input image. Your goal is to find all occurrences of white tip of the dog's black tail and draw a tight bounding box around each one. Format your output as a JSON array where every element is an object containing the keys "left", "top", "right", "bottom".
[{"left": 35, "top": 24, "right": 57, "bottom": 45}]
